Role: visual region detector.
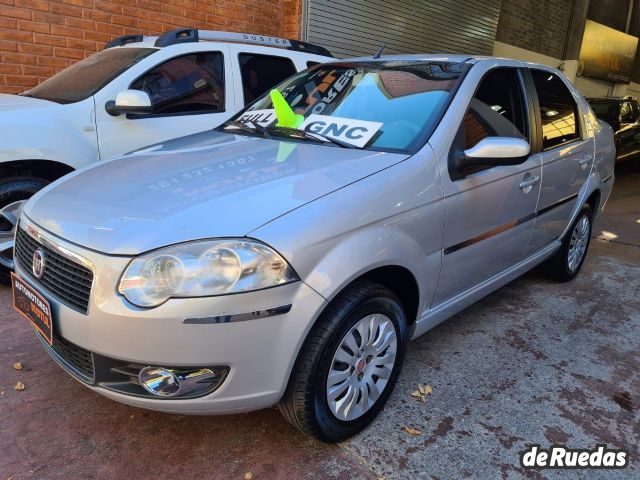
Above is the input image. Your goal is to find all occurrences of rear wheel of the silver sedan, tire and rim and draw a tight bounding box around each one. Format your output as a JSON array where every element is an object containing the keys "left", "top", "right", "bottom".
[{"left": 545, "top": 205, "right": 593, "bottom": 282}]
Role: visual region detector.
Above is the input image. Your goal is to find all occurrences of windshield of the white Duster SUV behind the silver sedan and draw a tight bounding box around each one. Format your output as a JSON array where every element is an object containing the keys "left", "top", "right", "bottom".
[{"left": 22, "top": 48, "right": 157, "bottom": 103}]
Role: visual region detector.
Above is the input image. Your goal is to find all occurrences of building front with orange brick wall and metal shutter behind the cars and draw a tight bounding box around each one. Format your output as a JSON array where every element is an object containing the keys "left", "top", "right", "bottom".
[{"left": 0, "top": 0, "right": 640, "bottom": 96}]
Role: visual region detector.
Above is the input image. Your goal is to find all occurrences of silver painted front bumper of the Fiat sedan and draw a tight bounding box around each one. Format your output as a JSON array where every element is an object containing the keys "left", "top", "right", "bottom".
[{"left": 16, "top": 217, "right": 325, "bottom": 414}]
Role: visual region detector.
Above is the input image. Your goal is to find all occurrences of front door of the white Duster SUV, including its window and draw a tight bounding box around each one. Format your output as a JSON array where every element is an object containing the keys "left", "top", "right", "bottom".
[{"left": 95, "top": 44, "right": 237, "bottom": 160}]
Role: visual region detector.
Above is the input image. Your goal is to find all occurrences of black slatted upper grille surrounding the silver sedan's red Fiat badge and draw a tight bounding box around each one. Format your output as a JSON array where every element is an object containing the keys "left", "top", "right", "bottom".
[{"left": 14, "top": 228, "right": 93, "bottom": 314}]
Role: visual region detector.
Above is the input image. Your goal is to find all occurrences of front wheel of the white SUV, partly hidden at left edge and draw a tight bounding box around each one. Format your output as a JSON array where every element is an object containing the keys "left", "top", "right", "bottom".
[{"left": 0, "top": 177, "right": 49, "bottom": 285}]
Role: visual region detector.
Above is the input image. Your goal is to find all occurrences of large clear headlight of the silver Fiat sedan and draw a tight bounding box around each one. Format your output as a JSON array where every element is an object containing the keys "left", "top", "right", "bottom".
[{"left": 118, "top": 239, "right": 298, "bottom": 307}]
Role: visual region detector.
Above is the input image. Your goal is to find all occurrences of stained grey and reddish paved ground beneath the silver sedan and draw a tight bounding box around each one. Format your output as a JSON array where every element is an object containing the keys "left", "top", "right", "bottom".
[{"left": 0, "top": 163, "right": 640, "bottom": 480}]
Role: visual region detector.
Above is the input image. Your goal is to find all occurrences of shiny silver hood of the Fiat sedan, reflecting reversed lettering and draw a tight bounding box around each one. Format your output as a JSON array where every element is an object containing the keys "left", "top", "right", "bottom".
[{"left": 25, "top": 127, "right": 407, "bottom": 255}]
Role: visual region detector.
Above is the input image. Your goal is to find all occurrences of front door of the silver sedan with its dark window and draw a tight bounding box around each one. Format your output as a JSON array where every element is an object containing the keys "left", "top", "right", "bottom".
[{"left": 434, "top": 68, "right": 541, "bottom": 305}]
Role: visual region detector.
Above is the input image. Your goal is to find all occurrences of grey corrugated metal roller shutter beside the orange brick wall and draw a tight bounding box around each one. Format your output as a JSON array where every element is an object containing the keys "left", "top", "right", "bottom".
[{"left": 303, "top": 0, "right": 502, "bottom": 57}]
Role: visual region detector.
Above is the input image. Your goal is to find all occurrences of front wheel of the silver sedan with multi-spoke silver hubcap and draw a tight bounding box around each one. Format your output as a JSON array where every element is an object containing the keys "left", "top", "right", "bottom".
[{"left": 278, "top": 281, "right": 408, "bottom": 443}]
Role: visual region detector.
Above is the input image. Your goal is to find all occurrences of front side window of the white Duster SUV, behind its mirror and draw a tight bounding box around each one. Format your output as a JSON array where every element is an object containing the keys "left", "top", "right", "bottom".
[{"left": 131, "top": 52, "right": 224, "bottom": 115}]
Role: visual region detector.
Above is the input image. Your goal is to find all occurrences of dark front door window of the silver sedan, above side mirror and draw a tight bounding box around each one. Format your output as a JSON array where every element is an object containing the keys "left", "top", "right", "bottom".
[{"left": 462, "top": 68, "right": 529, "bottom": 149}]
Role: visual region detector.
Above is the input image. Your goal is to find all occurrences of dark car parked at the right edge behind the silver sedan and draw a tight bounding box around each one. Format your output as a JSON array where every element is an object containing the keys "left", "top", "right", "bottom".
[{"left": 587, "top": 97, "right": 640, "bottom": 162}]
